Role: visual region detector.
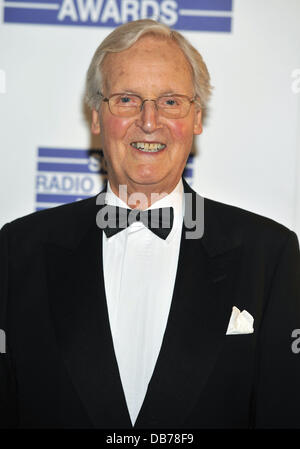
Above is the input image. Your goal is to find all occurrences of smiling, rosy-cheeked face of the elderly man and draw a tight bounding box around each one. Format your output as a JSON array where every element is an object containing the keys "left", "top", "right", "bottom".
[{"left": 92, "top": 36, "right": 202, "bottom": 193}]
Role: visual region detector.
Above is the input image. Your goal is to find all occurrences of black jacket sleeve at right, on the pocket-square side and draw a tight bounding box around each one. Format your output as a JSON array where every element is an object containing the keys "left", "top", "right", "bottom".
[{"left": 254, "top": 231, "right": 300, "bottom": 429}]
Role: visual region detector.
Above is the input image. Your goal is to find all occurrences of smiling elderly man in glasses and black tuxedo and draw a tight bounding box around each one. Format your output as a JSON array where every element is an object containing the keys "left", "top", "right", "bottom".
[{"left": 0, "top": 20, "right": 300, "bottom": 429}]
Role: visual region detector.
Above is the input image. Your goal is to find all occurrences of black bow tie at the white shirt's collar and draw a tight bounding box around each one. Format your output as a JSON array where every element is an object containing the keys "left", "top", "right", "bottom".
[{"left": 97, "top": 204, "right": 174, "bottom": 240}]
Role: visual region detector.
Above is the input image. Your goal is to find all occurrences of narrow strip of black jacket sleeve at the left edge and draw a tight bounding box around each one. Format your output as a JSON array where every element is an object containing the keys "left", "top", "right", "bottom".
[{"left": 0, "top": 225, "right": 18, "bottom": 429}]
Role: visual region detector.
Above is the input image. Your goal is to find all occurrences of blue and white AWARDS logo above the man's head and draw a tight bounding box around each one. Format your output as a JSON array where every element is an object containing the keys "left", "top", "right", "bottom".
[{"left": 3, "top": 0, "right": 232, "bottom": 32}]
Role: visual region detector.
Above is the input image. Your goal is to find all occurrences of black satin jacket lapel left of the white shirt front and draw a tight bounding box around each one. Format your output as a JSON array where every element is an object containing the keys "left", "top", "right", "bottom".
[{"left": 46, "top": 213, "right": 131, "bottom": 428}]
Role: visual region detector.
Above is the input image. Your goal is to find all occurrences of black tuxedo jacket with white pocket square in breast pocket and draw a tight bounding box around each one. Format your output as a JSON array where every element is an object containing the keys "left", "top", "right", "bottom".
[{"left": 0, "top": 181, "right": 300, "bottom": 429}]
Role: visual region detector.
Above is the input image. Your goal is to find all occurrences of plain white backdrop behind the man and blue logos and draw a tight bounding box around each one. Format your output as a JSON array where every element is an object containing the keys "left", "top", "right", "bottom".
[{"left": 0, "top": 0, "right": 300, "bottom": 240}]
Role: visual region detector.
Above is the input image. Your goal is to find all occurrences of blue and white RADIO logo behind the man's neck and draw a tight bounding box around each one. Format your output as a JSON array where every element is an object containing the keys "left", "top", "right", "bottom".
[{"left": 35, "top": 147, "right": 194, "bottom": 210}]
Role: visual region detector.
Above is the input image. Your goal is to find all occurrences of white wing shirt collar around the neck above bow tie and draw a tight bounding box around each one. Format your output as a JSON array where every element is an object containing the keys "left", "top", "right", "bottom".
[{"left": 105, "top": 178, "right": 184, "bottom": 243}]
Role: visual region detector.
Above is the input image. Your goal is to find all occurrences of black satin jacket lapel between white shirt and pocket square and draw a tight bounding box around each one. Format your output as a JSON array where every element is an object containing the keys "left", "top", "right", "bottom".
[{"left": 135, "top": 178, "right": 240, "bottom": 428}]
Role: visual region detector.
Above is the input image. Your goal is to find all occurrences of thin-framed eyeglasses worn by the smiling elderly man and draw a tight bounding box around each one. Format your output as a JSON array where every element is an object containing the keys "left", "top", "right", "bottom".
[{"left": 99, "top": 92, "right": 195, "bottom": 119}]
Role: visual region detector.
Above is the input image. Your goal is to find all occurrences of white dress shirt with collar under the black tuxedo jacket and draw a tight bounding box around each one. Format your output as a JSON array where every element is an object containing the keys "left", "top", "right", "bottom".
[{"left": 103, "top": 179, "right": 184, "bottom": 425}]
